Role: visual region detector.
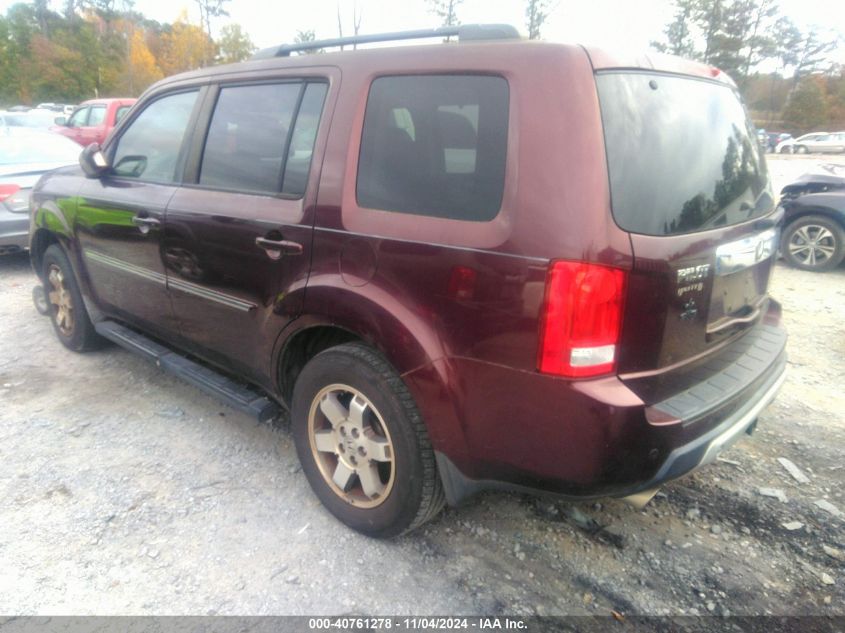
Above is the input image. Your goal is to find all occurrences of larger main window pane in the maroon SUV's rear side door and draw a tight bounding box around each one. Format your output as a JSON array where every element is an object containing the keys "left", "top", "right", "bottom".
[{"left": 200, "top": 83, "right": 302, "bottom": 193}]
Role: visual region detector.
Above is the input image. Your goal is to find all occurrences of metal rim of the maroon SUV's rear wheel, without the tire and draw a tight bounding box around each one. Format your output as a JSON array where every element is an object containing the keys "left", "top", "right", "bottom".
[{"left": 308, "top": 384, "right": 396, "bottom": 508}]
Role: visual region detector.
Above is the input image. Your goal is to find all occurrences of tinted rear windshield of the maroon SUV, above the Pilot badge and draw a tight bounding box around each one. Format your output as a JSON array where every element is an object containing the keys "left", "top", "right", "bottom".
[{"left": 596, "top": 71, "right": 772, "bottom": 235}]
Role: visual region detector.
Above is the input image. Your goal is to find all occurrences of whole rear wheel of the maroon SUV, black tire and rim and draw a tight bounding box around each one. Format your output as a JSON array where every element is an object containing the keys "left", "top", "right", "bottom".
[{"left": 291, "top": 343, "right": 445, "bottom": 538}]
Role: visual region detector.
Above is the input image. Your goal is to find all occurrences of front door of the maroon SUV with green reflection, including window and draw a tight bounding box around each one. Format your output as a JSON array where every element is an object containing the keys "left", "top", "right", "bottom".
[{"left": 75, "top": 90, "right": 198, "bottom": 334}]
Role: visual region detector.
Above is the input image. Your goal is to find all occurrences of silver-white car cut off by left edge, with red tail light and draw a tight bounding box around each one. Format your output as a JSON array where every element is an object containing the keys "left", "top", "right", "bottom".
[{"left": 0, "top": 127, "right": 79, "bottom": 254}]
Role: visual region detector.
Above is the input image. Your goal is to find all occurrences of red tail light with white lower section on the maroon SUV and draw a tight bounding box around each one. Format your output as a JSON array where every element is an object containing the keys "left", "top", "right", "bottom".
[{"left": 537, "top": 261, "right": 626, "bottom": 378}]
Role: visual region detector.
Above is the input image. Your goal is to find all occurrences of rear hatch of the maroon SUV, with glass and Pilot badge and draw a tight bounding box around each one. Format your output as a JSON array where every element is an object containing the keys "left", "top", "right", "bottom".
[{"left": 596, "top": 70, "right": 777, "bottom": 403}]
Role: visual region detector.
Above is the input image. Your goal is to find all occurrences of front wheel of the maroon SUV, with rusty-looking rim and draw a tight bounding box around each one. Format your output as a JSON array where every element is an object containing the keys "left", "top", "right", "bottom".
[{"left": 41, "top": 244, "right": 103, "bottom": 352}]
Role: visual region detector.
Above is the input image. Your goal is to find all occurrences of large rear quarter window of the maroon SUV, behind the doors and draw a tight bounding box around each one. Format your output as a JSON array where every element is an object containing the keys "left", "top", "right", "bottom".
[{"left": 357, "top": 75, "right": 508, "bottom": 221}]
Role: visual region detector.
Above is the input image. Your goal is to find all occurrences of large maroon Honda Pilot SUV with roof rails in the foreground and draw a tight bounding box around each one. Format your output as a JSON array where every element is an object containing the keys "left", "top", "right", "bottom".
[{"left": 31, "top": 26, "right": 786, "bottom": 537}]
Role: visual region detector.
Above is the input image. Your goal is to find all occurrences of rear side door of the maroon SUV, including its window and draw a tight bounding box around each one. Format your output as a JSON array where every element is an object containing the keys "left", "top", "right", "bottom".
[{"left": 163, "top": 80, "right": 328, "bottom": 383}]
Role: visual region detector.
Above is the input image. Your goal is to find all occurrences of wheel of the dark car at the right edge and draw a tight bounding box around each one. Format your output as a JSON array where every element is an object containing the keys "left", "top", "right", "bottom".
[{"left": 781, "top": 215, "right": 845, "bottom": 272}]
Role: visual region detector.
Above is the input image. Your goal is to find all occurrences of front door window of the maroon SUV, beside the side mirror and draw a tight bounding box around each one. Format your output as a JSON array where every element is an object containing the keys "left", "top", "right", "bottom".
[{"left": 112, "top": 92, "right": 197, "bottom": 182}]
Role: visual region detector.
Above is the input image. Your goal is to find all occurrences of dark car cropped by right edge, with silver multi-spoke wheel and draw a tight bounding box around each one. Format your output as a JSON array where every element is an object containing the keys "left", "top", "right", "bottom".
[{"left": 781, "top": 165, "right": 845, "bottom": 272}]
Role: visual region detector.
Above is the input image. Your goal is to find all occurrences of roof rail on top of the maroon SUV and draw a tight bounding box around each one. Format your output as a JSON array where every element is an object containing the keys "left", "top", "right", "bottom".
[{"left": 247, "top": 24, "right": 520, "bottom": 59}]
